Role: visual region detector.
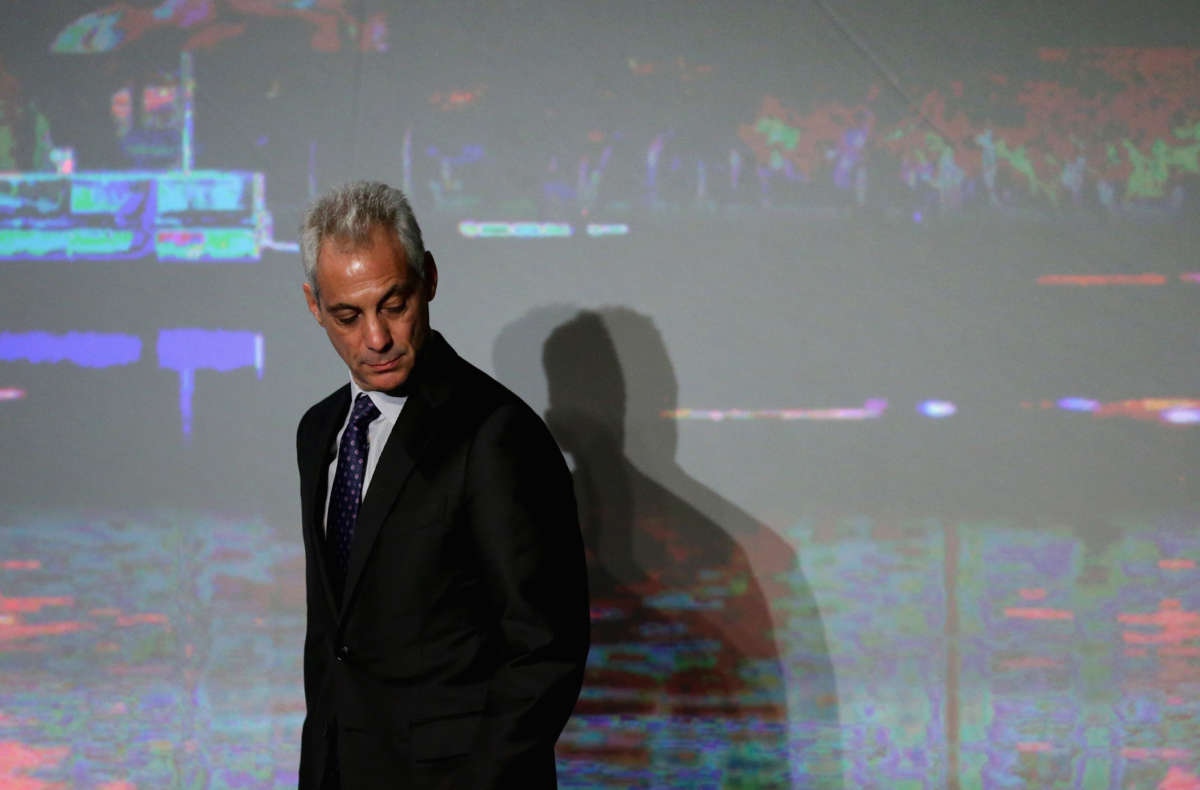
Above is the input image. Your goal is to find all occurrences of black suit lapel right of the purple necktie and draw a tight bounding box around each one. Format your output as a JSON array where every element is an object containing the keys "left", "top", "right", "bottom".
[{"left": 340, "top": 333, "right": 457, "bottom": 618}]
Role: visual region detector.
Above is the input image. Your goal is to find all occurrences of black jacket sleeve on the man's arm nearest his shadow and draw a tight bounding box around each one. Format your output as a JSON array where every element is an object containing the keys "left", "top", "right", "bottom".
[{"left": 466, "top": 403, "right": 589, "bottom": 788}]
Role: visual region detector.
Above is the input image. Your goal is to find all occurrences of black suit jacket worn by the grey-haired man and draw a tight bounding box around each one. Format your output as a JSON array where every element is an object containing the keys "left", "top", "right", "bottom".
[{"left": 296, "top": 333, "right": 588, "bottom": 790}]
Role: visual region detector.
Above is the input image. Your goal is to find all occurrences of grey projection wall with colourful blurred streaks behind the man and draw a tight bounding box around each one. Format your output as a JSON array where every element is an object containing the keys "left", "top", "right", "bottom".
[{"left": 0, "top": 0, "right": 1200, "bottom": 790}]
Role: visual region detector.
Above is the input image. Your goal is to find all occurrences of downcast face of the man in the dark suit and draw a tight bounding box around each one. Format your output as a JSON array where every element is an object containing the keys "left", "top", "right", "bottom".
[{"left": 304, "top": 227, "right": 438, "bottom": 391}]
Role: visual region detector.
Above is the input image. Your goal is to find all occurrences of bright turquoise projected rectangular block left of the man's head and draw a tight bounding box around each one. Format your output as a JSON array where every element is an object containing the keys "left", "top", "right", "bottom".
[{"left": 0, "top": 170, "right": 274, "bottom": 262}]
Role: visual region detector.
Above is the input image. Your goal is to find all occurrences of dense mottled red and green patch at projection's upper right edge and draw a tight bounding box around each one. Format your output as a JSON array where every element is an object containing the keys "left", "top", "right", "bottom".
[{"left": 731, "top": 47, "right": 1200, "bottom": 217}]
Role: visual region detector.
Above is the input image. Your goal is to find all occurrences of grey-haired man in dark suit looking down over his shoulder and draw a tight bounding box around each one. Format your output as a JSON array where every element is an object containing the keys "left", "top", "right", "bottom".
[{"left": 296, "top": 182, "right": 588, "bottom": 790}]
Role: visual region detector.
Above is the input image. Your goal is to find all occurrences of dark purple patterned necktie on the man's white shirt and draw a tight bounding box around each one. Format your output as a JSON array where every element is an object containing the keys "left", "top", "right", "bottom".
[{"left": 325, "top": 393, "right": 379, "bottom": 589}]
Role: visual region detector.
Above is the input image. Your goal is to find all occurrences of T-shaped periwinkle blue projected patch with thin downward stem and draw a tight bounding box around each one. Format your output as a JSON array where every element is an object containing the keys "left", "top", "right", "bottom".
[{"left": 158, "top": 329, "right": 263, "bottom": 441}]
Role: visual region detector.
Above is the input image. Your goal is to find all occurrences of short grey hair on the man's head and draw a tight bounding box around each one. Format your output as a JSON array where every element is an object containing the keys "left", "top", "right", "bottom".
[{"left": 300, "top": 181, "right": 425, "bottom": 300}]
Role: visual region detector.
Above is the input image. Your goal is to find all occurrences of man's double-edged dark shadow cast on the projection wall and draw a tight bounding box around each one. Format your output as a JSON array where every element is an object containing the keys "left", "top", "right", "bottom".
[{"left": 494, "top": 306, "right": 842, "bottom": 789}]
